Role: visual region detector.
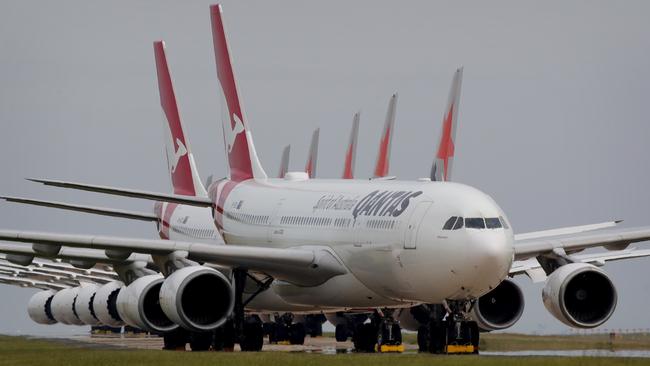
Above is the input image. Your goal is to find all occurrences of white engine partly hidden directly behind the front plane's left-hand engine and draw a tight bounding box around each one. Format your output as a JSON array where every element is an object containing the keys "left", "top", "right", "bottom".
[{"left": 117, "top": 274, "right": 178, "bottom": 333}]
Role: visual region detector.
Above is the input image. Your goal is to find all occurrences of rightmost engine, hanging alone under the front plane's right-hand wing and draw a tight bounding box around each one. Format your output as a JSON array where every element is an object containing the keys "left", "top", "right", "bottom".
[{"left": 542, "top": 263, "right": 617, "bottom": 328}]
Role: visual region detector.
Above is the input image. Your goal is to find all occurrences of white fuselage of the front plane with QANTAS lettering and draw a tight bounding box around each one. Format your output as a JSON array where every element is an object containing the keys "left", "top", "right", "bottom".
[{"left": 202, "top": 174, "right": 514, "bottom": 308}]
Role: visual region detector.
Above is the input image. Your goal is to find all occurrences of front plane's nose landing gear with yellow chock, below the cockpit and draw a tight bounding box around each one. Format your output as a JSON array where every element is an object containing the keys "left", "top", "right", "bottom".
[{"left": 417, "top": 301, "right": 479, "bottom": 354}]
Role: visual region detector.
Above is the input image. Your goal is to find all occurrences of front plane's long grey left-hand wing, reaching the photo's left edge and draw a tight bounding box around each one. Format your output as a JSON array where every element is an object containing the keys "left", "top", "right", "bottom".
[{"left": 0, "top": 230, "right": 347, "bottom": 286}]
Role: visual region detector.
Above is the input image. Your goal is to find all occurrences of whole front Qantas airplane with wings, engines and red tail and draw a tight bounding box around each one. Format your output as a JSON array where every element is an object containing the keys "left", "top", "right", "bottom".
[{"left": 0, "top": 5, "right": 650, "bottom": 353}]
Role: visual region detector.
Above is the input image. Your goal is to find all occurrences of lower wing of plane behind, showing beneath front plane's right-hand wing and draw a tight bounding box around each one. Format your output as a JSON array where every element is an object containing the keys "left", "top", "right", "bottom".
[{"left": 510, "top": 248, "right": 650, "bottom": 282}]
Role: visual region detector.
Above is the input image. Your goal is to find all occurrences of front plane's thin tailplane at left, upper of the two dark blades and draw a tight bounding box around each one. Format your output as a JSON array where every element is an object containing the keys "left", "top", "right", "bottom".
[{"left": 27, "top": 178, "right": 212, "bottom": 207}]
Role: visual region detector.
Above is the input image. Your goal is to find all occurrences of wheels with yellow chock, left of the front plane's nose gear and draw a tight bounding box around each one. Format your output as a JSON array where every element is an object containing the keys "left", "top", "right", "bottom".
[{"left": 352, "top": 310, "right": 404, "bottom": 353}]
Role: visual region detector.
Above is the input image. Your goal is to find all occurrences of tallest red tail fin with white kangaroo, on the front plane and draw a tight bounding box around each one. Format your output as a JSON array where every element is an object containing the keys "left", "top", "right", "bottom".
[{"left": 210, "top": 4, "right": 267, "bottom": 182}]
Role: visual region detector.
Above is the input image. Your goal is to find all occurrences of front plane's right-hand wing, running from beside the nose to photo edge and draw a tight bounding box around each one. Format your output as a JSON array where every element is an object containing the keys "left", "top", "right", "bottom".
[{"left": 514, "top": 226, "right": 650, "bottom": 260}]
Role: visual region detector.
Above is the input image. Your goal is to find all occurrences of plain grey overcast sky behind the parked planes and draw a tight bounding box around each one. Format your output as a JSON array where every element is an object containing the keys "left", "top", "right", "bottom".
[{"left": 0, "top": 0, "right": 650, "bottom": 334}]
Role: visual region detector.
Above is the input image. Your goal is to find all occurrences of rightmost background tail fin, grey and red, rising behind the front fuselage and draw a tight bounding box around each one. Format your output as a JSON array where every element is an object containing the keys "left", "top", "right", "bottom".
[{"left": 431, "top": 67, "right": 463, "bottom": 182}]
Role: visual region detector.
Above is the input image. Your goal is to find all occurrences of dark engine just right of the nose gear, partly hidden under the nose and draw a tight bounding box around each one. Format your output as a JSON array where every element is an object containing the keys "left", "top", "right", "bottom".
[{"left": 470, "top": 280, "right": 524, "bottom": 331}]
